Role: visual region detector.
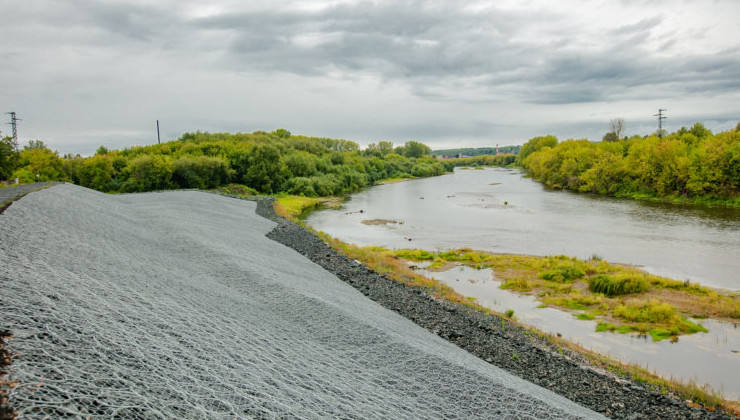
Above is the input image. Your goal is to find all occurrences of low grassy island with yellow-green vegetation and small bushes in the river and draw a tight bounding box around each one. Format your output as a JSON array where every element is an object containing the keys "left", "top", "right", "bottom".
[{"left": 388, "top": 248, "right": 740, "bottom": 340}]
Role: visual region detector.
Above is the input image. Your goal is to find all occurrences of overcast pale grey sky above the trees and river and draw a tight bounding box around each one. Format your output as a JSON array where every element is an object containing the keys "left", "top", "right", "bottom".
[{"left": 0, "top": 0, "right": 740, "bottom": 154}]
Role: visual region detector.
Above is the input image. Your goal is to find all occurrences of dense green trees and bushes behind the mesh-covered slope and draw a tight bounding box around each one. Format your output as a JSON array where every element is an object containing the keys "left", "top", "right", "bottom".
[{"left": 0, "top": 129, "right": 454, "bottom": 196}]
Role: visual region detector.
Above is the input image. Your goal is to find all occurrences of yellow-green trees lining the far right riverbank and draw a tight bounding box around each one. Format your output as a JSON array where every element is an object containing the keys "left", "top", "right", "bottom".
[{"left": 517, "top": 123, "right": 740, "bottom": 206}]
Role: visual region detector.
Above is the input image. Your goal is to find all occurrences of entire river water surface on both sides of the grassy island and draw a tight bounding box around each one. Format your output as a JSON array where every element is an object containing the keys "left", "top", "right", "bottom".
[{"left": 306, "top": 168, "right": 740, "bottom": 400}]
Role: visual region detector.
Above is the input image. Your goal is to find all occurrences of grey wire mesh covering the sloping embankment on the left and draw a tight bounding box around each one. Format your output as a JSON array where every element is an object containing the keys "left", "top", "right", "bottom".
[{"left": 0, "top": 185, "right": 598, "bottom": 419}]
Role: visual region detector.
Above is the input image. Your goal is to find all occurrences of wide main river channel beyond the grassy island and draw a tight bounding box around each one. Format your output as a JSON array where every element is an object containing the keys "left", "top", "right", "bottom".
[{"left": 307, "top": 169, "right": 740, "bottom": 290}]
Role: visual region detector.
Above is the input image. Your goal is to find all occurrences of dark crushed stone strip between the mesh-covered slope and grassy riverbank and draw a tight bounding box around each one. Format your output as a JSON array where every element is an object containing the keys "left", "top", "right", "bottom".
[{"left": 252, "top": 198, "right": 737, "bottom": 419}]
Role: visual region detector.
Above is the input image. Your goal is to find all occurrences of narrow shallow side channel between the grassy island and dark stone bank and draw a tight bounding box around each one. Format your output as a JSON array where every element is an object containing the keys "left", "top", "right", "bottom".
[{"left": 419, "top": 266, "right": 740, "bottom": 401}]
